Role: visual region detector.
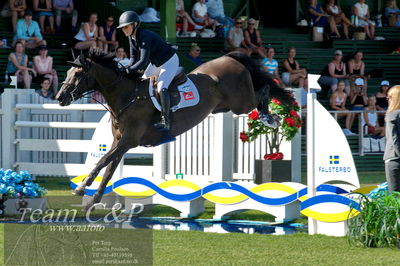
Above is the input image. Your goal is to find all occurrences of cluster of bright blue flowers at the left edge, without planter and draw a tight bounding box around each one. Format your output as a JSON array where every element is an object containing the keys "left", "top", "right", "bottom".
[{"left": 0, "top": 169, "right": 47, "bottom": 198}]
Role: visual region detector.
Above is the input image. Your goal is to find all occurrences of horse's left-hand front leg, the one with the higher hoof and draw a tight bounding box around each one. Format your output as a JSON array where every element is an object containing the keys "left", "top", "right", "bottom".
[{"left": 73, "top": 138, "right": 130, "bottom": 196}]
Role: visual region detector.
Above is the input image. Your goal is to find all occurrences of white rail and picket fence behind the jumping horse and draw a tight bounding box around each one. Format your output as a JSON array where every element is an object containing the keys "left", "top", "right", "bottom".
[{"left": 0, "top": 89, "right": 301, "bottom": 182}]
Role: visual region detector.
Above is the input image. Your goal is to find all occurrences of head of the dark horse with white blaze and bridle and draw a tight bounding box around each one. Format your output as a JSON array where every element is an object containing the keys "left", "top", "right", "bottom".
[{"left": 56, "top": 54, "right": 96, "bottom": 106}]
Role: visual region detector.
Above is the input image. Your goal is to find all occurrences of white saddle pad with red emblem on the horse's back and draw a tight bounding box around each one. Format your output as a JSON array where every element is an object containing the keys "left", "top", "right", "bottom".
[{"left": 149, "top": 78, "right": 200, "bottom": 112}]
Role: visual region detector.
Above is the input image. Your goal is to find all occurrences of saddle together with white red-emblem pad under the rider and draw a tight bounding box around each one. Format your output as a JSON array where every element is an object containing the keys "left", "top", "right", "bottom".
[{"left": 149, "top": 68, "right": 200, "bottom": 112}]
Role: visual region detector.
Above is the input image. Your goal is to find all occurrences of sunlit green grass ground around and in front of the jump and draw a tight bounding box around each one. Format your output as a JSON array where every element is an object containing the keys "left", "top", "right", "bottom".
[{"left": 0, "top": 172, "right": 400, "bottom": 265}]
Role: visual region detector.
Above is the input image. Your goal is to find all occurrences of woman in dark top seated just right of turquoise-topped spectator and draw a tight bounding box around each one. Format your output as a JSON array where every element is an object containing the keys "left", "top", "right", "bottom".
[{"left": 282, "top": 47, "right": 307, "bottom": 88}]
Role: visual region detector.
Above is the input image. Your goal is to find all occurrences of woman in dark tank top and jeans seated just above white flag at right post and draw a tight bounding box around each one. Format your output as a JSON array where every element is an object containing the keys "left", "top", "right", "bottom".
[{"left": 318, "top": 50, "right": 350, "bottom": 95}]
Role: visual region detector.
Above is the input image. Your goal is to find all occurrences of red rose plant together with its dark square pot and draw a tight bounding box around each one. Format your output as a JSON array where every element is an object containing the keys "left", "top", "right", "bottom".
[{"left": 240, "top": 98, "right": 302, "bottom": 184}]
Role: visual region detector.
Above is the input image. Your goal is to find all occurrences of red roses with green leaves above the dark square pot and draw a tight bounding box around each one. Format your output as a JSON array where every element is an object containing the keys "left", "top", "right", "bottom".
[{"left": 240, "top": 98, "right": 303, "bottom": 160}]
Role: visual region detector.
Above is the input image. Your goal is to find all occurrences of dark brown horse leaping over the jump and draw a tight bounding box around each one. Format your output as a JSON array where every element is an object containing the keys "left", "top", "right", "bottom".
[{"left": 56, "top": 49, "right": 294, "bottom": 211}]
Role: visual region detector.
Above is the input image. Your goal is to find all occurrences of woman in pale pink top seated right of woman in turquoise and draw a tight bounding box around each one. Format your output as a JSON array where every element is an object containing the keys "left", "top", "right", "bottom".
[{"left": 33, "top": 46, "right": 58, "bottom": 95}]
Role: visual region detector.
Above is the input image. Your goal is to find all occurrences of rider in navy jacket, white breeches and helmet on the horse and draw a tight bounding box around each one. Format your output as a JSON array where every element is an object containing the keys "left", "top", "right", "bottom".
[{"left": 118, "top": 11, "right": 179, "bottom": 129}]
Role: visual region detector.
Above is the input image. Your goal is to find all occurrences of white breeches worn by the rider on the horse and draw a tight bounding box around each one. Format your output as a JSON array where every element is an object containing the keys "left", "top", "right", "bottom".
[{"left": 143, "top": 54, "right": 179, "bottom": 92}]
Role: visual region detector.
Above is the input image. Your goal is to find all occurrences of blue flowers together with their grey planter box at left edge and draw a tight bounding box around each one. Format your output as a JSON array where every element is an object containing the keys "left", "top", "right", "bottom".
[{"left": 0, "top": 169, "right": 47, "bottom": 215}]
